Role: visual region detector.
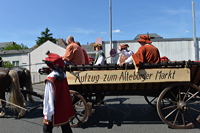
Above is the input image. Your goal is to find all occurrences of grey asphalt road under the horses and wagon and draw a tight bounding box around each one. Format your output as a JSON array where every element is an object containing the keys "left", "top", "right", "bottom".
[{"left": 0, "top": 83, "right": 200, "bottom": 133}]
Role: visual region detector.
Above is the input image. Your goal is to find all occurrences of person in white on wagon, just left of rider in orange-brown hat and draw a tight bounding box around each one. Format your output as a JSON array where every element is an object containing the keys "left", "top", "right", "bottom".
[{"left": 117, "top": 44, "right": 134, "bottom": 65}]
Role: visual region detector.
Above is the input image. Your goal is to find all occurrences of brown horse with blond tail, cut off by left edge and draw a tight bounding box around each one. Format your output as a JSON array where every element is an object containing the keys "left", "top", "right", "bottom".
[{"left": 0, "top": 67, "right": 25, "bottom": 117}]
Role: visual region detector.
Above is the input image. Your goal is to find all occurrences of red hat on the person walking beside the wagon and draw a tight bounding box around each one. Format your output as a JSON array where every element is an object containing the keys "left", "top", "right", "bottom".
[{"left": 45, "top": 53, "right": 65, "bottom": 69}]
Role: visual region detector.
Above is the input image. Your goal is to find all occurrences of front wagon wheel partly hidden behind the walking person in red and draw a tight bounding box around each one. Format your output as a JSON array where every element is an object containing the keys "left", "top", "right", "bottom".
[{"left": 70, "top": 90, "right": 88, "bottom": 127}]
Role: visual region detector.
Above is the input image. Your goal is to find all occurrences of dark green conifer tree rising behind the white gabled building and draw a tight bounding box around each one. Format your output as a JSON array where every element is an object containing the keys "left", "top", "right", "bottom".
[{"left": 36, "top": 28, "right": 56, "bottom": 46}]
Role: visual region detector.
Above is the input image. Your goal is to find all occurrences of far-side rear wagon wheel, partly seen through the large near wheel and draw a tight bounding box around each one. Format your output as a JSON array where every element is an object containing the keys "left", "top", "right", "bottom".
[{"left": 144, "top": 96, "right": 171, "bottom": 108}]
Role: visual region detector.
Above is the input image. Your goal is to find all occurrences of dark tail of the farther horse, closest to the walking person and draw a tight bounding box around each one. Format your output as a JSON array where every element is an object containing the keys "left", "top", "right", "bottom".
[{"left": 24, "top": 69, "right": 34, "bottom": 103}]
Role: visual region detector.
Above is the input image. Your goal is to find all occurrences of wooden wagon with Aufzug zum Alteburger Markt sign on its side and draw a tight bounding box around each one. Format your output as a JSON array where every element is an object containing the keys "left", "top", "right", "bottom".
[{"left": 65, "top": 61, "right": 200, "bottom": 128}]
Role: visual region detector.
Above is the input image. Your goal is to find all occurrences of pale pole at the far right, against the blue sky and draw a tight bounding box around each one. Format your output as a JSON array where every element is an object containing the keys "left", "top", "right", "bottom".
[{"left": 192, "top": 1, "right": 199, "bottom": 61}]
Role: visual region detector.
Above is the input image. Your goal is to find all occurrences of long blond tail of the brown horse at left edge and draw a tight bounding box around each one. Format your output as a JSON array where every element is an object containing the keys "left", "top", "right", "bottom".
[{"left": 8, "top": 70, "right": 25, "bottom": 112}]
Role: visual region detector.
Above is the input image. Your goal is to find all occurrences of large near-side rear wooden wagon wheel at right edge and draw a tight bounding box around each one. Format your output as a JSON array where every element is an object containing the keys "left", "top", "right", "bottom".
[{"left": 157, "top": 83, "right": 200, "bottom": 129}]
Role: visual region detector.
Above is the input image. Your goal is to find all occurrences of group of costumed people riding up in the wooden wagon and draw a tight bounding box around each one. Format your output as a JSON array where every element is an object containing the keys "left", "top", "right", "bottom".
[{"left": 61, "top": 35, "right": 162, "bottom": 67}]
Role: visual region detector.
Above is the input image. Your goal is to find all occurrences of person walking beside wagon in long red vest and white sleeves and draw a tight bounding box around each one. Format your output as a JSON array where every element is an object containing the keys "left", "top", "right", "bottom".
[{"left": 43, "top": 53, "right": 74, "bottom": 133}]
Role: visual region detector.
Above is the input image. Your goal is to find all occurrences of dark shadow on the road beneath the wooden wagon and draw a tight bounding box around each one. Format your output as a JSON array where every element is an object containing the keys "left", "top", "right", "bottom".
[{"left": 81, "top": 98, "right": 163, "bottom": 128}]
